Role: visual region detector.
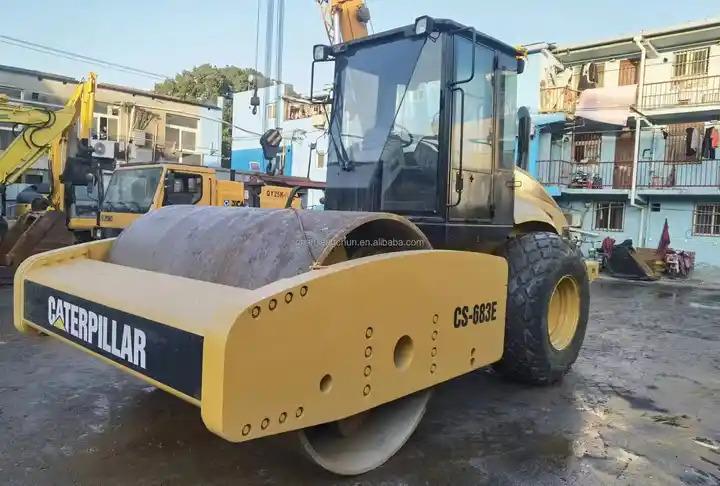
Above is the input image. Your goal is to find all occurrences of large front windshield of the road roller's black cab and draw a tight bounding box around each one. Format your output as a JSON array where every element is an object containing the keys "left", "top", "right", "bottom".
[{"left": 326, "top": 36, "right": 442, "bottom": 213}]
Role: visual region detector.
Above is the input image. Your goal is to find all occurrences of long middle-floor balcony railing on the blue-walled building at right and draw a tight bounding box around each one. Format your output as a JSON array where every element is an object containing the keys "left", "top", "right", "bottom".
[{"left": 537, "top": 160, "right": 720, "bottom": 190}]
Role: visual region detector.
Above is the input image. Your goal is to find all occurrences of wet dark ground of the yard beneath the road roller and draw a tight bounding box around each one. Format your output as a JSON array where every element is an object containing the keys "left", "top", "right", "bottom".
[{"left": 0, "top": 281, "right": 720, "bottom": 485}]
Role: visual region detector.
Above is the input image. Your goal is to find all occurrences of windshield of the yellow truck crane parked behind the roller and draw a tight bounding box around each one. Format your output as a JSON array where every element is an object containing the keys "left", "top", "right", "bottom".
[{"left": 103, "top": 167, "right": 162, "bottom": 213}]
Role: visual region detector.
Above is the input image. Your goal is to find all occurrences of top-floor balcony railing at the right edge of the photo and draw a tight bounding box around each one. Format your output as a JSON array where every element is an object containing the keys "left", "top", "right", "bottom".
[{"left": 642, "top": 76, "right": 720, "bottom": 109}]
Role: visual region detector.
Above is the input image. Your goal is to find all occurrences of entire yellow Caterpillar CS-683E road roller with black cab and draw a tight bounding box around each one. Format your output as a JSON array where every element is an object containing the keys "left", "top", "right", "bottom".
[{"left": 14, "top": 17, "right": 589, "bottom": 475}]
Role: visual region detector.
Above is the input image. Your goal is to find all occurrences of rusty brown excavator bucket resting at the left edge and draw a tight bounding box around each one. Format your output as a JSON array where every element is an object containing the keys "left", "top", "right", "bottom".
[{"left": 0, "top": 211, "right": 75, "bottom": 270}]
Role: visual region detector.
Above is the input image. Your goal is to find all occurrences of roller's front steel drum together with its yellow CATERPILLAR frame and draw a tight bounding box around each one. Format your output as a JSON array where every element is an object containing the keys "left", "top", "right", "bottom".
[{"left": 14, "top": 206, "right": 508, "bottom": 474}]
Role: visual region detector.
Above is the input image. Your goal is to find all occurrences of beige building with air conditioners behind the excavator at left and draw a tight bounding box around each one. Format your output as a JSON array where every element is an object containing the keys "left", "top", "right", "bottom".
[{"left": 0, "top": 66, "right": 222, "bottom": 212}]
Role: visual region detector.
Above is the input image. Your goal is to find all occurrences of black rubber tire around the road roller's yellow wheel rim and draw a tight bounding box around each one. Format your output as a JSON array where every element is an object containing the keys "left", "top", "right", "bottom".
[{"left": 494, "top": 232, "right": 590, "bottom": 385}]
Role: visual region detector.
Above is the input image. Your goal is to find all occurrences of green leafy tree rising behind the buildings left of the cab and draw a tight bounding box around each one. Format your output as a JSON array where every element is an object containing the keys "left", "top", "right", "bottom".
[{"left": 154, "top": 64, "right": 271, "bottom": 167}]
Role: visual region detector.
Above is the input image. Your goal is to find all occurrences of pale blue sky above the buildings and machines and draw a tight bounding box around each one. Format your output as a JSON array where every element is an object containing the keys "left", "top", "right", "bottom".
[{"left": 0, "top": 0, "right": 720, "bottom": 93}]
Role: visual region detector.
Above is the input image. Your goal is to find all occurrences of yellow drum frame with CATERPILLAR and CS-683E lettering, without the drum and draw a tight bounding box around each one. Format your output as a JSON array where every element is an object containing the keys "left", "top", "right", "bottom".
[{"left": 14, "top": 234, "right": 507, "bottom": 442}]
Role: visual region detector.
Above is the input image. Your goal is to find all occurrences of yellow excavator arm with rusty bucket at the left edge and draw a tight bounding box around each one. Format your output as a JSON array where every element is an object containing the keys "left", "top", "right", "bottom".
[{"left": 0, "top": 73, "right": 104, "bottom": 268}]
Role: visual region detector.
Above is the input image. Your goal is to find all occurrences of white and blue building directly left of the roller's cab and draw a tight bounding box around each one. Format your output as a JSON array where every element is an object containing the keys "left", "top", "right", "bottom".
[{"left": 231, "top": 84, "right": 329, "bottom": 205}]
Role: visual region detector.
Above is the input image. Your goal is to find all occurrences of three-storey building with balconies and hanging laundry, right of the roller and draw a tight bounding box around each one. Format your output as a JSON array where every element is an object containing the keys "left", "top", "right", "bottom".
[{"left": 520, "top": 19, "right": 720, "bottom": 265}]
